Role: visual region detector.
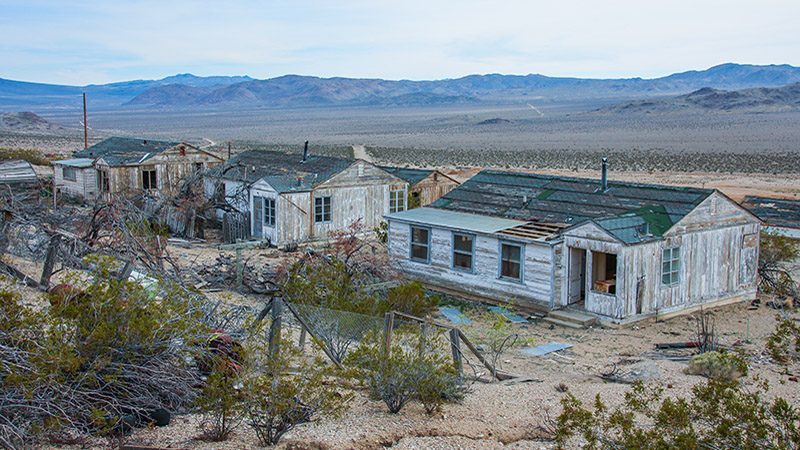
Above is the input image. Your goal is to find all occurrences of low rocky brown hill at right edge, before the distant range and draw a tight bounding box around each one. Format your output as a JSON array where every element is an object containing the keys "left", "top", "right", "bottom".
[{"left": 596, "top": 83, "right": 800, "bottom": 114}]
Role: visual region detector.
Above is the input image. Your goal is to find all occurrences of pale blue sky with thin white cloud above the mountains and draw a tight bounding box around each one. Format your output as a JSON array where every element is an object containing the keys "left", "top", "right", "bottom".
[{"left": 0, "top": 0, "right": 800, "bottom": 84}]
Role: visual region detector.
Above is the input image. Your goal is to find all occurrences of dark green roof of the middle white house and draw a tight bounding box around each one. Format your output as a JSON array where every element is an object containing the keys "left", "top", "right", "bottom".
[{"left": 208, "top": 150, "right": 355, "bottom": 192}]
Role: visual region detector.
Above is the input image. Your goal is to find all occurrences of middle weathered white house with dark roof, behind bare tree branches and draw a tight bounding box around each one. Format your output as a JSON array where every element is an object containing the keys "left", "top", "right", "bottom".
[{"left": 205, "top": 149, "right": 408, "bottom": 246}]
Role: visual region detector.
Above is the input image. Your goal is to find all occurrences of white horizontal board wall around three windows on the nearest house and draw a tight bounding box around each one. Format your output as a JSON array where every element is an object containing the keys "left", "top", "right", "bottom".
[{"left": 389, "top": 220, "right": 554, "bottom": 308}]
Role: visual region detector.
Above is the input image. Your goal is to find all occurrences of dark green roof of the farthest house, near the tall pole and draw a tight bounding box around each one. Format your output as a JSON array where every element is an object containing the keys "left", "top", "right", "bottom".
[{"left": 75, "top": 137, "right": 180, "bottom": 166}]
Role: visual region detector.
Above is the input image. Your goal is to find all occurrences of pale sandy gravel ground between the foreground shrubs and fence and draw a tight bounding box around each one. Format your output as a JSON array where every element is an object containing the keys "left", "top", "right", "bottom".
[{"left": 3, "top": 236, "right": 800, "bottom": 449}]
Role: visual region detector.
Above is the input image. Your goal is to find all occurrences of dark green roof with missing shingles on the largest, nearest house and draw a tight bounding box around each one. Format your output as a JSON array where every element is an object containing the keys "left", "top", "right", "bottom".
[{"left": 431, "top": 170, "right": 714, "bottom": 243}]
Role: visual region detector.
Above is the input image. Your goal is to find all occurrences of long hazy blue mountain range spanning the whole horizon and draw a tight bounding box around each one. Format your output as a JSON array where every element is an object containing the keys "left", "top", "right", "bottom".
[{"left": 0, "top": 63, "right": 800, "bottom": 111}]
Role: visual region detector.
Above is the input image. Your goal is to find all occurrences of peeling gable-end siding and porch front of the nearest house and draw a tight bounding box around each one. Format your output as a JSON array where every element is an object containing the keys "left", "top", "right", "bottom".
[{"left": 562, "top": 194, "right": 760, "bottom": 320}]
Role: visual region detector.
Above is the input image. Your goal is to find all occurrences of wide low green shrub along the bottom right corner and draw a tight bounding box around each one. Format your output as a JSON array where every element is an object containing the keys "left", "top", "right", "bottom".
[{"left": 554, "top": 379, "right": 800, "bottom": 450}]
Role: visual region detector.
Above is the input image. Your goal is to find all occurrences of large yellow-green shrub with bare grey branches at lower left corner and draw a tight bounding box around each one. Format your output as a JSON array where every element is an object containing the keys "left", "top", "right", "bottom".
[{"left": 0, "top": 258, "right": 208, "bottom": 447}]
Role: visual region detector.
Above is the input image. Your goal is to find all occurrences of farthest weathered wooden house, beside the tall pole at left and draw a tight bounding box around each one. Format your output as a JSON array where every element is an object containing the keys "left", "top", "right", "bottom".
[{"left": 53, "top": 137, "right": 223, "bottom": 199}]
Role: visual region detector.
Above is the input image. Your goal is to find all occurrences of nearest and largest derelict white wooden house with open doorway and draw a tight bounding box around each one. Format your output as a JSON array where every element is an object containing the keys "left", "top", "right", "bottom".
[{"left": 387, "top": 164, "right": 761, "bottom": 324}]
